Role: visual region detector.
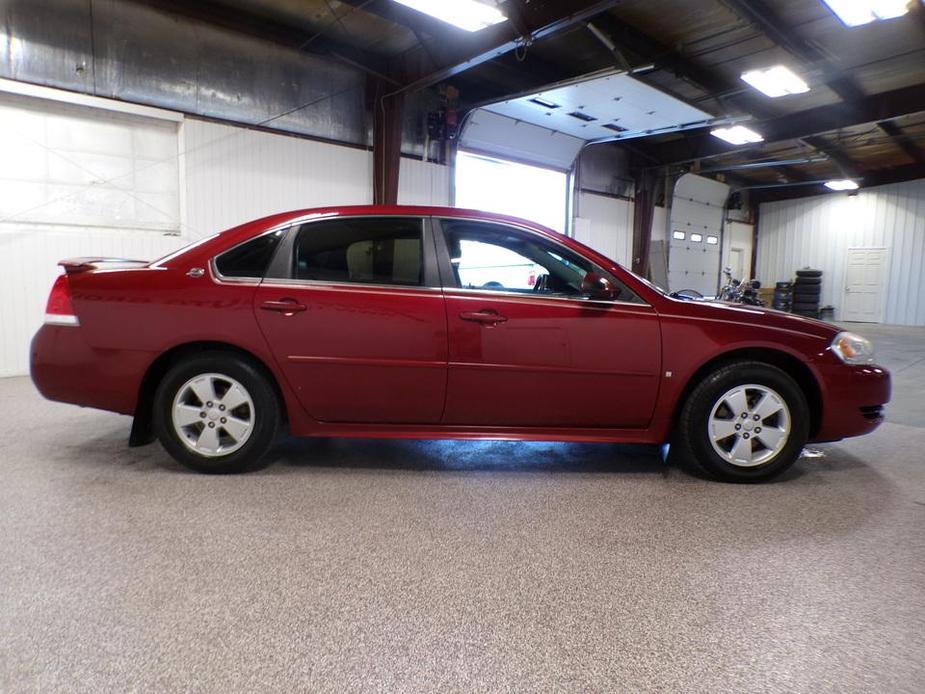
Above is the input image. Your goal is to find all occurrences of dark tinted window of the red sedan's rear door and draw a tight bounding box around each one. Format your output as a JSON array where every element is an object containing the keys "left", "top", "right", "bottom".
[{"left": 292, "top": 217, "right": 424, "bottom": 286}]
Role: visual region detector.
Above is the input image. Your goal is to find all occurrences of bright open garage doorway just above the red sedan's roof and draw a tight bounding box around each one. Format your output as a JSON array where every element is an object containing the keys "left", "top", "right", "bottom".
[{"left": 456, "top": 151, "right": 568, "bottom": 233}]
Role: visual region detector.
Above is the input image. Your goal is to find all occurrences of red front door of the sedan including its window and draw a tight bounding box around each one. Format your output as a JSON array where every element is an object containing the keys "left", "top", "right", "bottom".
[{"left": 441, "top": 219, "right": 661, "bottom": 429}]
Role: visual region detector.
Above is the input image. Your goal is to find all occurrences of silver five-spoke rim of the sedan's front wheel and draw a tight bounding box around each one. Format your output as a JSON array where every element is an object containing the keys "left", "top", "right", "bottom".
[{"left": 707, "top": 383, "right": 791, "bottom": 467}]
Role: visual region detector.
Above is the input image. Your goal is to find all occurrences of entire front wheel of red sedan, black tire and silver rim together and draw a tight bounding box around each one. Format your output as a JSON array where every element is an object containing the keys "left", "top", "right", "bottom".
[{"left": 671, "top": 361, "right": 809, "bottom": 482}]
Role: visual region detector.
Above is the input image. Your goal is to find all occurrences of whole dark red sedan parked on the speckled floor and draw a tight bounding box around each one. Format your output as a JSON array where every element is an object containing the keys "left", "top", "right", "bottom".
[{"left": 31, "top": 206, "right": 890, "bottom": 481}]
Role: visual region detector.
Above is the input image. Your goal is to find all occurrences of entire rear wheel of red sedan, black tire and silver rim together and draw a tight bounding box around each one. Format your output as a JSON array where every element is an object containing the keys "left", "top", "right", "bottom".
[{"left": 153, "top": 351, "right": 280, "bottom": 474}]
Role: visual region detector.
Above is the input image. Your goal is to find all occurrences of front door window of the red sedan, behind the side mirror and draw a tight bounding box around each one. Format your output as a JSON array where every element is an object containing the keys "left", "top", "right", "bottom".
[{"left": 442, "top": 220, "right": 636, "bottom": 301}]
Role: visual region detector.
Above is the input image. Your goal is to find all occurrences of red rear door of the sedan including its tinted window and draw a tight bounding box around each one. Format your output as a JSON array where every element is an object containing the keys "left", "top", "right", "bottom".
[{"left": 249, "top": 216, "right": 447, "bottom": 424}]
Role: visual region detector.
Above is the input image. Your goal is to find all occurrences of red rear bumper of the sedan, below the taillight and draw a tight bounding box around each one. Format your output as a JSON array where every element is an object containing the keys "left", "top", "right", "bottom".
[{"left": 29, "top": 325, "right": 154, "bottom": 414}]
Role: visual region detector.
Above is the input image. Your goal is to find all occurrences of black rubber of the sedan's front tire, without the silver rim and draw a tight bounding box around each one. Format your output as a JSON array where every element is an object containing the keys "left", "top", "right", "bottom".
[{"left": 670, "top": 361, "right": 809, "bottom": 482}]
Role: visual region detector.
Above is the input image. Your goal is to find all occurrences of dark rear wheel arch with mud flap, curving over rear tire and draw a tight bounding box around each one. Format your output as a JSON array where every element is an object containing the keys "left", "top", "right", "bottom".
[{"left": 129, "top": 340, "right": 288, "bottom": 446}]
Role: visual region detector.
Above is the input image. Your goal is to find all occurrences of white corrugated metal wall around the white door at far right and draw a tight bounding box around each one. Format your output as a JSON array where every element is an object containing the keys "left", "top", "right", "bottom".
[{"left": 758, "top": 180, "right": 925, "bottom": 325}]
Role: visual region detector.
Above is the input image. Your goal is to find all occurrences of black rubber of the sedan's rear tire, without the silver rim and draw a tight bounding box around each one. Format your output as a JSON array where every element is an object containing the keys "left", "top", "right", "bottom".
[{"left": 153, "top": 351, "right": 281, "bottom": 474}]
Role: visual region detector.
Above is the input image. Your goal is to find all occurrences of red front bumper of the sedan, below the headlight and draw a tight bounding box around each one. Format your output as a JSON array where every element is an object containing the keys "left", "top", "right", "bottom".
[{"left": 813, "top": 363, "right": 891, "bottom": 443}]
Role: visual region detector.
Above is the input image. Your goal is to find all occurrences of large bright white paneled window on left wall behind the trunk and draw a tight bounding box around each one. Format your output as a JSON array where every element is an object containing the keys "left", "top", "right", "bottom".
[{"left": 0, "top": 94, "right": 180, "bottom": 233}]
